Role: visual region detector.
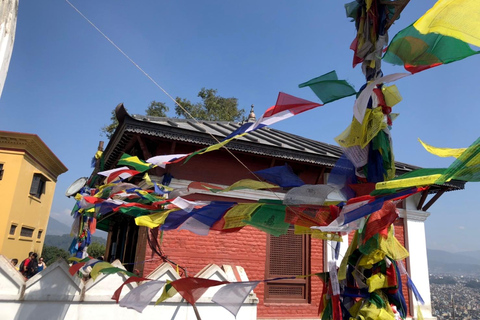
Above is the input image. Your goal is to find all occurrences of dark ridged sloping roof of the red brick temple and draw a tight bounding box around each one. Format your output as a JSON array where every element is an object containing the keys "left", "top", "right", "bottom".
[{"left": 99, "top": 104, "right": 465, "bottom": 192}]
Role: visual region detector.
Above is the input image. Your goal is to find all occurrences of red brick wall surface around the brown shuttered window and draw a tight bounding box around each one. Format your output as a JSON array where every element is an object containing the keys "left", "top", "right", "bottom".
[{"left": 144, "top": 226, "right": 323, "bottom": 319}]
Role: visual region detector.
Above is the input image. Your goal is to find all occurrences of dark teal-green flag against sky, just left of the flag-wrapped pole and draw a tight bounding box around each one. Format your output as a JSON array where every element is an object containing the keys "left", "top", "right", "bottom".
[{"left": 298, "top": 71, "right": 357, "bottom": 104}]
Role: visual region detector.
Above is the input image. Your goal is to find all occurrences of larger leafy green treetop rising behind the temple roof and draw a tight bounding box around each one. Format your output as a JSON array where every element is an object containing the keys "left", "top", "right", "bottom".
[{"left": 175, "top": 88, "right": 245, "bottom": 121}]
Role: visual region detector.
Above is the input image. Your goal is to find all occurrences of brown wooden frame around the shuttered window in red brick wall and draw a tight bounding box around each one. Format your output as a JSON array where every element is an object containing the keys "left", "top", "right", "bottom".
[{"left": 265, "top": 228, "right": 311, "bottom": 303}]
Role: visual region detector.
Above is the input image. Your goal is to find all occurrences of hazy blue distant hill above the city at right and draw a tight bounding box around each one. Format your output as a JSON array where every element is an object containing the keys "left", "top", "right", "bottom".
[{"left": 427, "top": 249, "right": 480, "bottom": 275}]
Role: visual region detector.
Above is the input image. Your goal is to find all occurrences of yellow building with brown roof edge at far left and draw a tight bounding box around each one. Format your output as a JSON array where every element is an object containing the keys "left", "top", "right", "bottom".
[{"left": 0, "top": 131, "right": 67, "bottom": 261}]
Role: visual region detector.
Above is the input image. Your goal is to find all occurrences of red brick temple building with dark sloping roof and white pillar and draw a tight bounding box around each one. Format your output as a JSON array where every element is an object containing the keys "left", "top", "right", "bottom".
[{"left": 84, "top": 104, "right": 464, "bottom": 319}]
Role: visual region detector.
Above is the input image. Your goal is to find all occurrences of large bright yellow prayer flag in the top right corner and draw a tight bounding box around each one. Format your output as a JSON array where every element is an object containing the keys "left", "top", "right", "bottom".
[{"left": 413, "top": 0, "right": 480, "bottom": 47}]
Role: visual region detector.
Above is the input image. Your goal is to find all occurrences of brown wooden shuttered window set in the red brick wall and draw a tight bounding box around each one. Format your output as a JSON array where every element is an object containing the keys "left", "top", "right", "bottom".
[{"left": 265, "top": 229, "right": 310, "bottom": 303}]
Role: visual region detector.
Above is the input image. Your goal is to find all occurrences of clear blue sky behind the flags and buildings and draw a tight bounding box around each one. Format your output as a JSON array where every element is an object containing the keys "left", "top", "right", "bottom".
[{"left": 0, "top": 0, "right": 480, "bottom": 251}]
